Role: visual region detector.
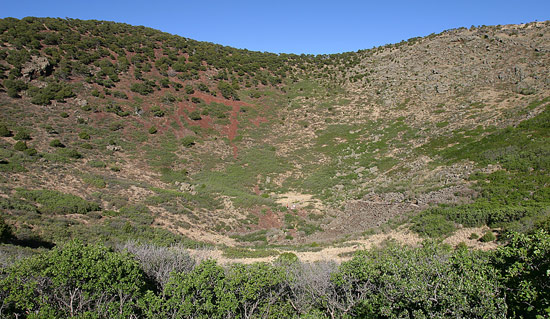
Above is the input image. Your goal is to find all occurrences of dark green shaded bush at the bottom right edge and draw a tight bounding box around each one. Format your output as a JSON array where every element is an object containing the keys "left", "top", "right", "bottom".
[{"left": 495, "top": 230, "right": 550, "bottom": 318}]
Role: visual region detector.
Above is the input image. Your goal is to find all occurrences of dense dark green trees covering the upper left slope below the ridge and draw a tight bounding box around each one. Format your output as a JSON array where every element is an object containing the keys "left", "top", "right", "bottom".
[{"left": 0, "top": 17, "right": 364, "bottom": 105}]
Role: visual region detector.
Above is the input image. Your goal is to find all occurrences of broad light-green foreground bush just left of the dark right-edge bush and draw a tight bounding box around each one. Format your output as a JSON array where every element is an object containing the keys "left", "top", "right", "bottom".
[{"left": 333, "top": 244, "right": 506, "bottom": 318}]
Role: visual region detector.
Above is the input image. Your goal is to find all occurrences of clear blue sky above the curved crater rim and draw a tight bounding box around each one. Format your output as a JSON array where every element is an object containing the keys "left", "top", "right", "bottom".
[{"left": 0, "top": 0, "right": 550, "bottom": 54}]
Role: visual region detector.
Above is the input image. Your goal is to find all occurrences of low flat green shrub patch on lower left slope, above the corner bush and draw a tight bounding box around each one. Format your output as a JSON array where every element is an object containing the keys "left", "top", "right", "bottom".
[{"left": 17, "top": 189, "right": 100, "bottom": 215}]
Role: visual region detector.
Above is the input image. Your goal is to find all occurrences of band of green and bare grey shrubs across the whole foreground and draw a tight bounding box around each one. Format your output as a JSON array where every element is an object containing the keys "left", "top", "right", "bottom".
[{"left": 0, "top": 231, "right": 550, "bottom": 318}]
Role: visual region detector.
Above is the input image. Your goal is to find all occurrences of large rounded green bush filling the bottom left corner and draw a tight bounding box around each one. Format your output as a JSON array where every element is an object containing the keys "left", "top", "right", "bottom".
[{"left": 0, "top": 241, "right": 145, "bottom": 318}]
